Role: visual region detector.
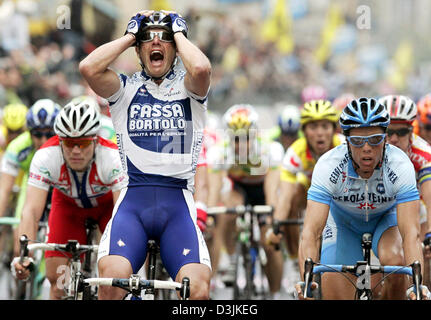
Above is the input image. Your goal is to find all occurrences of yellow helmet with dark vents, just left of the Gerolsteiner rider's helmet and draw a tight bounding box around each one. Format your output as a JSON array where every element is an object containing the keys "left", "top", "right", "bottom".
[{"left": 301, "top": 100, "right": 338, "bottom": 127}]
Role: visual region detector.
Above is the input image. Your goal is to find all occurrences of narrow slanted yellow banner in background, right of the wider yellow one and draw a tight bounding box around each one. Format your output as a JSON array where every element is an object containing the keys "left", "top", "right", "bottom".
[{"left": 315, "top": 3, "right": 345, "bottom": 64}]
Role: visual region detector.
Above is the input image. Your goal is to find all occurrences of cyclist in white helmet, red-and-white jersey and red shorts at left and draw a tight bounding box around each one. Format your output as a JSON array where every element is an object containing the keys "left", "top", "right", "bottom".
[{"left": 12, "top": 101, "right": 127, "bottom": 299}]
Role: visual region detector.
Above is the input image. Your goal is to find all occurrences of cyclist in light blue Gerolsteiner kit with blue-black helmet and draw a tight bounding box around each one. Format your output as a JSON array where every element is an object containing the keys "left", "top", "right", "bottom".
[{"left": 296, "top": 98, "right": 429, "bottom": 299}]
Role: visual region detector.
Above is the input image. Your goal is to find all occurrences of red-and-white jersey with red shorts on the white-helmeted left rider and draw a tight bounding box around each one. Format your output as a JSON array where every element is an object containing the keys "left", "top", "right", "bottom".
[{"left": 28, "top": 136, "right": 127, "bottom": 258}]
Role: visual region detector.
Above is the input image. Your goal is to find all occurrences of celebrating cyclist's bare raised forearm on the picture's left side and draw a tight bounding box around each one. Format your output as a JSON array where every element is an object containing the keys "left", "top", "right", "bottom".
[{"left": 79, "top": 33, "right": 135, "bottom": 76}]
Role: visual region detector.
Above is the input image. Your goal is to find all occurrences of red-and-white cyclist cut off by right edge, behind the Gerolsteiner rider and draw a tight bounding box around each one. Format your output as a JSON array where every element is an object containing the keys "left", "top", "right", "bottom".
[{"left": 379, "top": 95, "right": 431, "bottom": 285}]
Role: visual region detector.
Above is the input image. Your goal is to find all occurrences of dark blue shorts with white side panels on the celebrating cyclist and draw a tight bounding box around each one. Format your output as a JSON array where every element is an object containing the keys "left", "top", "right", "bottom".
[{"left": 97, "top": 186, "right": 211, "bottom": 279}]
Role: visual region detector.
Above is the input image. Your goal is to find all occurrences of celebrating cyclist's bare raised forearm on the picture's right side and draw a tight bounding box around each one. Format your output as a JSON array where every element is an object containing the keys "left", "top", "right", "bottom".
[{"left": 174, "top": 32, "right": 211, "bottom": 82}]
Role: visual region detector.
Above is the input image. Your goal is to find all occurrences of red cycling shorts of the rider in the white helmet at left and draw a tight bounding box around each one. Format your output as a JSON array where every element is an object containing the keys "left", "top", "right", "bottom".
[{"left": 45, "top": 189, "right": 114, "bottom": 258}]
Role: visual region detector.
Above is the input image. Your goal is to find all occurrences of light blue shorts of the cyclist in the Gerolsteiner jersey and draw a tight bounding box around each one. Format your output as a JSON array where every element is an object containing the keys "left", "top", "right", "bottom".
[{"left": 320, "top": 206, "right": 397, "bottom": 265}]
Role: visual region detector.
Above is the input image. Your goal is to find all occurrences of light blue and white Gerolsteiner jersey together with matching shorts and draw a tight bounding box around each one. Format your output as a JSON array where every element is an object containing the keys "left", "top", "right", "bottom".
[{"left": 308, "top": 144, "right": 419, "bottom": 263}]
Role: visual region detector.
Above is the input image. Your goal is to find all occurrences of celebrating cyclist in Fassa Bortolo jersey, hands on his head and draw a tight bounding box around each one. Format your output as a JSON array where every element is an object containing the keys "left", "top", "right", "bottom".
[{"left": 80, "top": 10, "right": 211, "bottom": 299}]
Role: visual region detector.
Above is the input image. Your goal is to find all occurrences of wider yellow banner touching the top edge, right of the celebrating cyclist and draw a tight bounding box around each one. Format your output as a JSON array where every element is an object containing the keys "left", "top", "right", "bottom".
[{"left": 261, "top": 0, "right": 294, "bottom": 54}]
